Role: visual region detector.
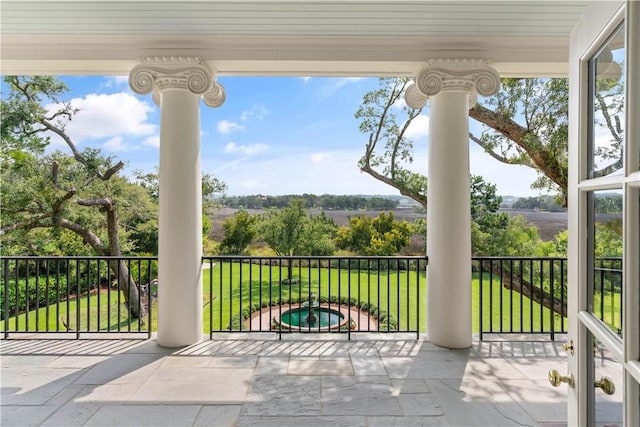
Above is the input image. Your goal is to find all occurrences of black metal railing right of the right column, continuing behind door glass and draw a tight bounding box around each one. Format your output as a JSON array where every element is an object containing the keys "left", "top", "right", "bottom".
[{"left": 473, "top": 257, "right": 622, "bottom": 340}]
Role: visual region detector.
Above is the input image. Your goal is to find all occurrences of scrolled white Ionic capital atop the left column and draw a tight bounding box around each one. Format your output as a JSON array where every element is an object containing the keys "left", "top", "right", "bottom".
[{"left": 129, "top": 56, "right": 225, "bottom": 107}]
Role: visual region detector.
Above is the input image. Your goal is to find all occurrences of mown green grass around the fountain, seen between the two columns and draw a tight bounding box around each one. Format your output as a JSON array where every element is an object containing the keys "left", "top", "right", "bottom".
[{"left": 204, "top": 263, "right": 426, "bottom": 330}]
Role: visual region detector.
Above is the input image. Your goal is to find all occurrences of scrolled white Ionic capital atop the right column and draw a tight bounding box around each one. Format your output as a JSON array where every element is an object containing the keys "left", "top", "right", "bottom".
[{"left": 405, "top": 59, "right": 500, "bottom": 108}]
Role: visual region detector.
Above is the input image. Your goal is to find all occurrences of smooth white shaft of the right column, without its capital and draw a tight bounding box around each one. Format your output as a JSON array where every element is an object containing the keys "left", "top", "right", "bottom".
[{"left": 427, "top": 89, "right": 472, "bottom": 348}]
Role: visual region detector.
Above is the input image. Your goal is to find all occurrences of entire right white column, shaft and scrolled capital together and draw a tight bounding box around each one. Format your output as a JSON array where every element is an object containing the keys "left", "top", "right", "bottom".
[{"left": 406, "top": 60, "right": 500, "bottom": 348}]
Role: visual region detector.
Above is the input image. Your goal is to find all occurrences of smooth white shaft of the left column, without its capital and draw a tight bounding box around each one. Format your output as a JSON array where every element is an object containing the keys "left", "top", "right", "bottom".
[{"left": 158, "top": 89, "right": 203, "bottom": 347}]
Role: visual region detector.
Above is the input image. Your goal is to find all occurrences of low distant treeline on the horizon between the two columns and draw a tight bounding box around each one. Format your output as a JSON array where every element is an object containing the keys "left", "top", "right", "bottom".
[{"left": 219, "top": 194, "right": 398, "bottom": 211}]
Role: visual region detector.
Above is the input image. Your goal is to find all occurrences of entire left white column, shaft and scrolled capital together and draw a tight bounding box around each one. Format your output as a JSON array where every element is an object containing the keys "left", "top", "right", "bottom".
[{"left": 129, "top": 57, "right": 224, "bottom": 347}]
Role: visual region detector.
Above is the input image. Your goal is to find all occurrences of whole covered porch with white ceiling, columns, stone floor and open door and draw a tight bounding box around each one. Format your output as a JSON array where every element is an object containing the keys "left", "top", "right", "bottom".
[{"left": 0, "top": 0, "right": 640, "bottom": 426}]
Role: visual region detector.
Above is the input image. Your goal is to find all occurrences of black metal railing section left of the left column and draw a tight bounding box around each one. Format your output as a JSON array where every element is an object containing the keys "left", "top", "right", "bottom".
[{"left": 0, "top": 256, "right": 157, "bottom": 338}]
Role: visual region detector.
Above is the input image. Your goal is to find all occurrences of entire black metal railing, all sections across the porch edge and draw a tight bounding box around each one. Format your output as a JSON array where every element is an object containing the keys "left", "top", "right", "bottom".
[{"left": 0, "top": 256, "right": 622, "bottom": 340}]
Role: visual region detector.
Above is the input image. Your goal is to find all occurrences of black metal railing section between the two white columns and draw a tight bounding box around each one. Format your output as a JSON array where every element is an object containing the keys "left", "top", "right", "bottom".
[{"left": 203, "top": 256, "right": 427, "bottom": 338}]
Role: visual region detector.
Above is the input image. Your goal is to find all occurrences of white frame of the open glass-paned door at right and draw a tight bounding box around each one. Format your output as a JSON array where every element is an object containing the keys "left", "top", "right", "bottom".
[{"left": 567, "top": 2, "right": 640, "bottom": 425}]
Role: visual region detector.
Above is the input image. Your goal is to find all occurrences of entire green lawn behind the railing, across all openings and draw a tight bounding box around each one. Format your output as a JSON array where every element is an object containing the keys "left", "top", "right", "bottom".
[{"left": 0, "top": 263, "right": 621, "bottom": 333}]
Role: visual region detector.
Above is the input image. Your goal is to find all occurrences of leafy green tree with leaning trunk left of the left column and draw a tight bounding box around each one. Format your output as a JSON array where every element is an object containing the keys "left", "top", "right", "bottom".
[{"left": 0, "top": 76, "right": 145, "bottom": 317}]
